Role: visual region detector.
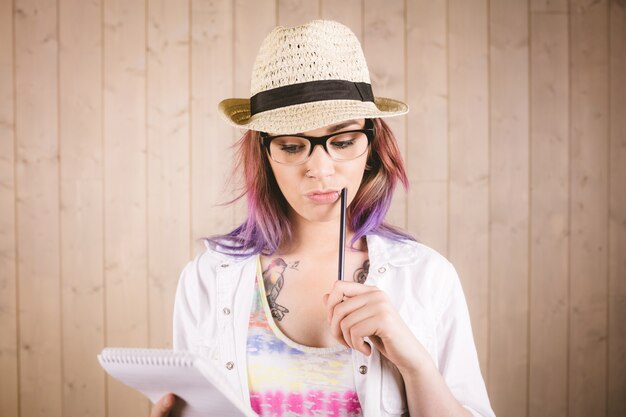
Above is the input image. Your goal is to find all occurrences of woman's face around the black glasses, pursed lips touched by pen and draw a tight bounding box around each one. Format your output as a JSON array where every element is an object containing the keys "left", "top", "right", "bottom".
[{"left": 268, "top": 119, "right": 369, "bottom": 226}]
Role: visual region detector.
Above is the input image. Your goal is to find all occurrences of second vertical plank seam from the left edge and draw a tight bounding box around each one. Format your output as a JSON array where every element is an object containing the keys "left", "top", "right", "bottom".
[{"left": 55, "top": 0, "right": 65, "bottom": 415}]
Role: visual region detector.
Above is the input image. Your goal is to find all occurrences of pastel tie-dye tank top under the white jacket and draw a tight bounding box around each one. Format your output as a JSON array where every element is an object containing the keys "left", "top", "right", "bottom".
[{"left": 247, "top": 263, "right": 362, "bottom": 417}]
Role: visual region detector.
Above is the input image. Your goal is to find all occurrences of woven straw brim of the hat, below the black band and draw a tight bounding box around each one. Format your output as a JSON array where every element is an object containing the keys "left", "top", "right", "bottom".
[{"left": 218, "top": 97, "right": 409, "bottom": 134}]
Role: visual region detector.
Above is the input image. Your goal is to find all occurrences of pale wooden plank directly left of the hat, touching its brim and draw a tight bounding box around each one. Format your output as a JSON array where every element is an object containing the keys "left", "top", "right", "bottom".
[{"left": 190, "top": 0, "right": 235, "bottom": 255}]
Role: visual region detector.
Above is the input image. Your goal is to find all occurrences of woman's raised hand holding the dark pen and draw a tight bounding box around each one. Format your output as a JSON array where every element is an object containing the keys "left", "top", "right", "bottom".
[{"left": 324, "top": 281, "right": 430, "bottom": 375}]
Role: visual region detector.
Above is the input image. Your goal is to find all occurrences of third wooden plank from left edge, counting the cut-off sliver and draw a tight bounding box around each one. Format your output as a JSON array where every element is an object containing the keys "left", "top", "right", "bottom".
[{"left": 59, "top": 0, "right": 106, "bottom": 416}]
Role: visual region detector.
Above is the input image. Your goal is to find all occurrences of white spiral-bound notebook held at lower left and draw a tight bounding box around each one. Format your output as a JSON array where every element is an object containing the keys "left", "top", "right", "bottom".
[{"left": 98, "top": 348, "right": 258, "bottom": 417}]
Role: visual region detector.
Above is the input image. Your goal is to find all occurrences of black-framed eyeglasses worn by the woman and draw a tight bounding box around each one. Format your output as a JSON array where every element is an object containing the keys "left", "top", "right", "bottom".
[{"left": 261, "top": 119, "right": 374, "bottom": 165}]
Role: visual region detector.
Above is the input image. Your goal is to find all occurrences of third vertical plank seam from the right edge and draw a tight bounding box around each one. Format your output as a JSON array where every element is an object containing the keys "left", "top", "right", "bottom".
[{"left": 525, "top": 0, "right": 533, "bottom": 417}]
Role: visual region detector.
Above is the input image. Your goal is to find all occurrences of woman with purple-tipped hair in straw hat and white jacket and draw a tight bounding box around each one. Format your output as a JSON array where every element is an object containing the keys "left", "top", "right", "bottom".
[{"left": 152, "top": 21, "right": 493, "bottom": 416}]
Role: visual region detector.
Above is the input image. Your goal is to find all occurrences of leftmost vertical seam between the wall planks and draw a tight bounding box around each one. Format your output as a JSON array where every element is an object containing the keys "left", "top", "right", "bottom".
[{"left": 11, "top": 0, "right": 22, "bottom": 417}]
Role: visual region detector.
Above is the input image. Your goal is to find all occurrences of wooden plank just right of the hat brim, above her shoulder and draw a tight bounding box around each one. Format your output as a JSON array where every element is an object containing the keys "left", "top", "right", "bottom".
[{"left": 405, "top": 0, "right": 449, "bottom": 255}]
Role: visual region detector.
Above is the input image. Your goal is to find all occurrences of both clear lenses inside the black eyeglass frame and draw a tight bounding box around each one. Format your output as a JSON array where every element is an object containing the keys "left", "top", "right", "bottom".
[{"left": 269, "top": 132, "right": 368, "bottom": 165}]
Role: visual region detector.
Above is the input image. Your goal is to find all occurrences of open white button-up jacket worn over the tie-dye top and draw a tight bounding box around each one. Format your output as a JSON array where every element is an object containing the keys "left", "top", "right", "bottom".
[{"left": 174, "top": 232, "right": 494, "bottom": 417}]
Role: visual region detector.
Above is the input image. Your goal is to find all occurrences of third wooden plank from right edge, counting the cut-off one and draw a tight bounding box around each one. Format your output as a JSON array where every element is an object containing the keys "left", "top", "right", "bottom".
[{"left": 528, "top": 12, "right": 570, "bottom": 417}]
